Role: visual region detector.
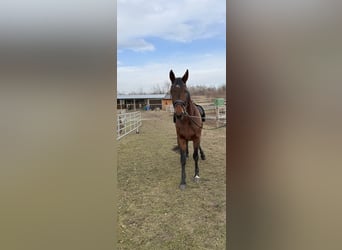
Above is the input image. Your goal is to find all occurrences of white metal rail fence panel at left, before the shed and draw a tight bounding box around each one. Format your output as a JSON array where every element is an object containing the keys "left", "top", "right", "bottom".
[{"left": 117, "top": 111, "right": 142, "bottom": 140}]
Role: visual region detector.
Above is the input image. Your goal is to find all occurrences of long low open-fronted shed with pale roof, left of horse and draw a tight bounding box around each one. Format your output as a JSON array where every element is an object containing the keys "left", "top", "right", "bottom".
[{"left": 117, "top": 94, "right": 172, "bottom": 110}]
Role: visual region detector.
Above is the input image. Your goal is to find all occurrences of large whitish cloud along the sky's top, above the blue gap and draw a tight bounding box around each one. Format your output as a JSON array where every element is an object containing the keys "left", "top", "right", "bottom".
[{"left": 117, "top": 0, "right": 226, "bottom": 51}]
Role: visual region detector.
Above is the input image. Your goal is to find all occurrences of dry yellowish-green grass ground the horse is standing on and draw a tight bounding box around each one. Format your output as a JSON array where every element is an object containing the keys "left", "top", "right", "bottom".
[{"left": 117, "top": 111, "right": 226, "bottom": 250}]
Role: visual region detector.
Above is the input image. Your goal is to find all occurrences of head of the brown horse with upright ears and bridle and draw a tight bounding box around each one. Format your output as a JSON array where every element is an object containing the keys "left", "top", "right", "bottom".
[{"left": 170, "top": 70, "right": 190, "bottom": 119}]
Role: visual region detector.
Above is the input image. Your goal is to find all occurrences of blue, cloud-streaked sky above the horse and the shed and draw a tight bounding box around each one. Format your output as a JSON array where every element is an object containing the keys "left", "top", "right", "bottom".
[{"left": 117, "top": 0, "right": 226, "bottom": 94}]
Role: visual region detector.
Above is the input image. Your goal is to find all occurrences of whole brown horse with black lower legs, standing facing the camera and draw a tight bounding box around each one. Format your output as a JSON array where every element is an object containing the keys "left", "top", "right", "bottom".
[{"left": 170, "top": 70, "right": 205, "bottom": 190}]
